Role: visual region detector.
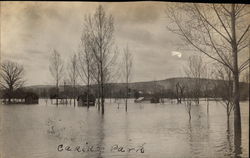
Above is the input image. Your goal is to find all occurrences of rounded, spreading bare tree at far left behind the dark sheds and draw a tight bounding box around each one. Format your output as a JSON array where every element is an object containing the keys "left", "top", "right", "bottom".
[{"left": 0, "top": 61, "right": 24, "bottom": 103}]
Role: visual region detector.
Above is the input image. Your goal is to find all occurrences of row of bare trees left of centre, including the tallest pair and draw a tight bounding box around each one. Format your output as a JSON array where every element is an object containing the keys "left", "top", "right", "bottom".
[{"left": 50, "top": 6, "right": 133, "bottom": 114}]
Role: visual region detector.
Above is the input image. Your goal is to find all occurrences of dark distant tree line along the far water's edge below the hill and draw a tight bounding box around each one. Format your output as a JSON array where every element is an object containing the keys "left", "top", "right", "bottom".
[{"left": 8, "top": 78, "right": 249, "bottom": 102}]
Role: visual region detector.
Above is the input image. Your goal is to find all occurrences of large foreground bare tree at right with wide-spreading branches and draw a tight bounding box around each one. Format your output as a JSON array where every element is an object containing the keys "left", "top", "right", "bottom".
[{"left": 166, "top": 4, "right": 250, "bottom": 133}]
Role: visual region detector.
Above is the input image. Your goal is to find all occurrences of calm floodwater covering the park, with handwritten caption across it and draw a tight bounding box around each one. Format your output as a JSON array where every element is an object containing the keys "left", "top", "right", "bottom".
[{"left": 0, "top": 100, "right": 249, "bottom": 158}]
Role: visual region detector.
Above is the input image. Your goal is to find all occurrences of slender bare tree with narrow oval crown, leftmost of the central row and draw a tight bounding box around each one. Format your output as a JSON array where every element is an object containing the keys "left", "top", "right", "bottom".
[{"left": 49, "top": 49, "right": 63, "bottom": 105}]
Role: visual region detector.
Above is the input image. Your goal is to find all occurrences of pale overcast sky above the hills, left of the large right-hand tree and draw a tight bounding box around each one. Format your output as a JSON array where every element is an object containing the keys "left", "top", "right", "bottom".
[{"left": 1, "top": 2, "right": 221, "bottom": 85}]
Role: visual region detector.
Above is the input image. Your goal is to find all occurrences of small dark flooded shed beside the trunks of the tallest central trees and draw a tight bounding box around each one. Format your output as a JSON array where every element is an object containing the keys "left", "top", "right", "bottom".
[{"left": 77, "top": 93, "right": 96, "bottom": 106}]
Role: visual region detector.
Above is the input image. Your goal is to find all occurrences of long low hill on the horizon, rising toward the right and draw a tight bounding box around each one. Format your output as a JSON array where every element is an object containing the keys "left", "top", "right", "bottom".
[{"left": 24, "top": 77, "right": 249, "bottom": 97}]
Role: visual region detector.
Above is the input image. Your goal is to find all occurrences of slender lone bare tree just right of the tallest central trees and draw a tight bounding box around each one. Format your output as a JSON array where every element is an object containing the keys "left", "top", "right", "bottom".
[{"left": 122, "top": 45, "right": 133, "bottom": 112}]
